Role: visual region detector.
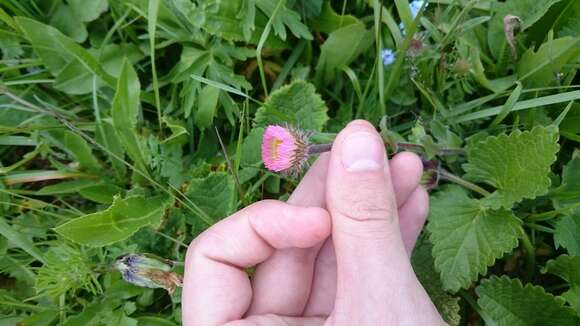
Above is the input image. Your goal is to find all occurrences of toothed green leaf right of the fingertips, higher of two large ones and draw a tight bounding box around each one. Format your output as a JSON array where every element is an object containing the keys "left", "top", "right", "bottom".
[{"left": 463, "top": 126, "right": 559, "bottom": 208}]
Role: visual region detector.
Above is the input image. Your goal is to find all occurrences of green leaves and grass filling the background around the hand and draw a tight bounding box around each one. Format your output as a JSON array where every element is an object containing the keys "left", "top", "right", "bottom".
[{"left": 0, "top": 0, "right": 580, "bottom": 325}]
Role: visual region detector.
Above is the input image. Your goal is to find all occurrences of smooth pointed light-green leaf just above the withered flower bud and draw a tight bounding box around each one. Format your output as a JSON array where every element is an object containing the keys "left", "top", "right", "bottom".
[{"left": 54, "top": 196, "right": 169, "bottom": 247}]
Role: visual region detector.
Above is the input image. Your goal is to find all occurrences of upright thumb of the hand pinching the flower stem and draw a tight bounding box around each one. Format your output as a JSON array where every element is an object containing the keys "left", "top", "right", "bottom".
[{"left": 326, "top": 120, "right": 413, "bottom": 308}]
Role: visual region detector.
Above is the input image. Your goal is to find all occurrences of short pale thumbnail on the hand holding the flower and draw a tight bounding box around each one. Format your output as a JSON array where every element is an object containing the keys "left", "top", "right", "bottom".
[{"left": 342, "top": 131, "right": 385, "bottom": 172}]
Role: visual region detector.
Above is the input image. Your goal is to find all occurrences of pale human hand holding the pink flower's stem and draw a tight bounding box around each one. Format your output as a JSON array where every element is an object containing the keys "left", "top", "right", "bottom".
[{"left": 182, "top": 121, "right": 444, "bottom": 326}]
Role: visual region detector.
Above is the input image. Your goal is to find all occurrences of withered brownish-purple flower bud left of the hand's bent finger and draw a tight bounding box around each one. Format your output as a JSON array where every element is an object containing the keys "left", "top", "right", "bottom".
[{"left": 114, "top": 254, "right": 183, "bottom": 293}]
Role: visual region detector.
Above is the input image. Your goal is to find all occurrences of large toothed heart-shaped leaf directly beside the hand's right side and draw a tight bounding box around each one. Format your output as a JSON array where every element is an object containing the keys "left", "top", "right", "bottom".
[{"left": 427, "top": 186, "right": 521, "bottom": 292}]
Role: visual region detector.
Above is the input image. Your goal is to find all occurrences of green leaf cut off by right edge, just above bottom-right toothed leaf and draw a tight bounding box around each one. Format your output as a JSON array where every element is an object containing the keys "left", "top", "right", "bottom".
[{"left": 542, "top": 255, "right": 580, "bottom": 316}]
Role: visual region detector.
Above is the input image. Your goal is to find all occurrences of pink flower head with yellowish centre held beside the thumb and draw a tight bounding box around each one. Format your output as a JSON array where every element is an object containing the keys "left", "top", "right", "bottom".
[{"left": 262, "top": 125, "right": 308, "bottom": 174}]
